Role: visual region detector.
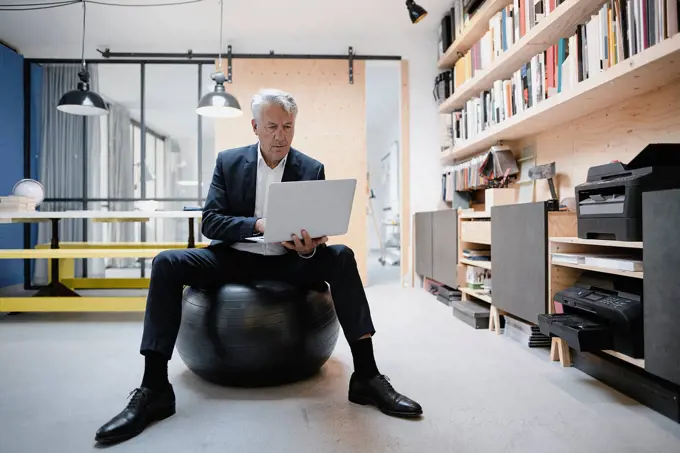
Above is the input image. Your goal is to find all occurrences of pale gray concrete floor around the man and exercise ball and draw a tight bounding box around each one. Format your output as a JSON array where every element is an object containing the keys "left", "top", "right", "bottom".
[{"left": 0, "top": 285, "right": 680, "bottom": 453}]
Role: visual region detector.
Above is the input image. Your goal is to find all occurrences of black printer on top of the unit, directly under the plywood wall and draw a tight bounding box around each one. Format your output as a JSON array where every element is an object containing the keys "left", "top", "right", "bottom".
[{"left": 575, "top": 144, "right": 680, "bottom": 241}]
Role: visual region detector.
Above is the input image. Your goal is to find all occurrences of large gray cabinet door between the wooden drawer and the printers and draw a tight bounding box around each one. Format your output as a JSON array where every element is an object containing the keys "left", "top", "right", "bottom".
[{"left": 491, "top": 202, "right": 548, "bottom": 324}]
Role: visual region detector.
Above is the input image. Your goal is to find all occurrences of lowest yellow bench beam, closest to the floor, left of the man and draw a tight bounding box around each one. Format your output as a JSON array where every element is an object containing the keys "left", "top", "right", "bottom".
[{"left": 0, "top": 296, "right": 146, "bottom": 313}]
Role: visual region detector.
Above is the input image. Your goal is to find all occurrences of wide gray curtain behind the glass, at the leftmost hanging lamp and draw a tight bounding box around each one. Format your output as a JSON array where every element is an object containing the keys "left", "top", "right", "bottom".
[{"left": 34, "top": 64, "right": 101, "bottom": 283}]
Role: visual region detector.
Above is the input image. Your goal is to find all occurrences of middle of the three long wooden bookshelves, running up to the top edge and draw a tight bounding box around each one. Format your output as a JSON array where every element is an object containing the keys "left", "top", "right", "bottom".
[{"left": 439, "top": 0, "right": 605, "bottom": 113}]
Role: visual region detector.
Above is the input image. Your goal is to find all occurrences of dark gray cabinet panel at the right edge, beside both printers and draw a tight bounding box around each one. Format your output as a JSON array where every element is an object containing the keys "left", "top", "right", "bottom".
[{"left": 642, "top": 190, "right": 680, "bottom": 385}]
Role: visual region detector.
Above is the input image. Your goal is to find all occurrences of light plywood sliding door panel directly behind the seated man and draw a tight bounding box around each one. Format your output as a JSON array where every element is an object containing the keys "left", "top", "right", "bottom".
[{"left": 215, "top": 59, "right": 368, "bottom": 284}]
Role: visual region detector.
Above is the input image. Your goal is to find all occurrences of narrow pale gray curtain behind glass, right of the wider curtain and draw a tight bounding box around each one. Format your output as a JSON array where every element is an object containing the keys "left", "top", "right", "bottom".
[{"left": 107, "top": 104, "right": 139, "bottom": 267}]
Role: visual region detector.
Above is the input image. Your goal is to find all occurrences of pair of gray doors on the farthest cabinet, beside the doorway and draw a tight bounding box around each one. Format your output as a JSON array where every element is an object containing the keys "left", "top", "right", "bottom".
[{"left": 414, "top": 209, "right": 458, "bottom": 288}]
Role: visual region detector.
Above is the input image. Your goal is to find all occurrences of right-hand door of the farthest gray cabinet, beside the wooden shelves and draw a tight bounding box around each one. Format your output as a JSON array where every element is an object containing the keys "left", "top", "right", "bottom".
[{"left": 432, "top": 209, "right": 458, "bottom": 288}]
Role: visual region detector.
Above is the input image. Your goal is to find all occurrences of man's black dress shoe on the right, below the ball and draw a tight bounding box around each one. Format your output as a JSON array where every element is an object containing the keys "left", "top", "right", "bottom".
[{"left": 349, "top": 373, "right": 423, "bottom": 417}]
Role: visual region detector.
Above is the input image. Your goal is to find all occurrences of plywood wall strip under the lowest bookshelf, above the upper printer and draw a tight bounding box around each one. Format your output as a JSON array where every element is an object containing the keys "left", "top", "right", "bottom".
[{"left": 512, "top": 83, "right": 680, "bottom": 201}]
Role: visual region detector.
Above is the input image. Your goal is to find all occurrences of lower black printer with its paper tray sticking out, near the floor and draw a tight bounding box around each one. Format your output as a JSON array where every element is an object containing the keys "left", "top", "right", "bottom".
[{"left": 538, "top": 272, "right": 644, "bottom": 358}]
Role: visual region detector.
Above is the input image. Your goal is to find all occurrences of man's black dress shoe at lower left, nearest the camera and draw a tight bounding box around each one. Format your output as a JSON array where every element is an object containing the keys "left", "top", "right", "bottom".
[{"left": 95, "top": 385, "right": 175, "bottom": 443}]
